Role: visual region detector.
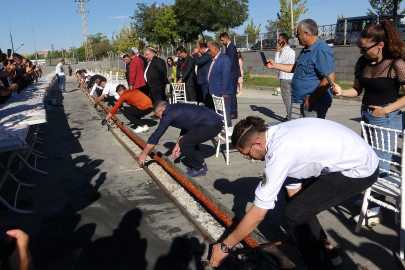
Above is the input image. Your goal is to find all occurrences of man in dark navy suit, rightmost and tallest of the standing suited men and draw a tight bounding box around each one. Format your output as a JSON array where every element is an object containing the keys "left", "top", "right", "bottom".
[{"left": 220, "top": 33, "right": 240, "bottom": 119}]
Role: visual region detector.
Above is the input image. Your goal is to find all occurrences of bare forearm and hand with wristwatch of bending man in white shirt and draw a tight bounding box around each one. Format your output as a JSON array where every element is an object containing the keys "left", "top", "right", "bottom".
[{"left": 210, "top": 205, "right": 267, "bottom": 267}]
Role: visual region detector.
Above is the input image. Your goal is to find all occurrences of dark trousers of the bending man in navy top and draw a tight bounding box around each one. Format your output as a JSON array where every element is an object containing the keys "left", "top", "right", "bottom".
[{"left": 179, "top": 121, "right": 223, "bottom": 170}]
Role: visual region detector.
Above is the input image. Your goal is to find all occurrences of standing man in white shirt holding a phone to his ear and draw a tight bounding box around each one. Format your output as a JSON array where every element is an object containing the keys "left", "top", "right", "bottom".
[{"left": 274, "top": 33, "right": 295, "bottom": 121}]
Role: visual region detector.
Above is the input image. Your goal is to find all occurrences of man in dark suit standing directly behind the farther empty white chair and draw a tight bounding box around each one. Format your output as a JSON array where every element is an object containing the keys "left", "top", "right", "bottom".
[{"left": 176, "top": 46, "right": 197, "bottom": 101}]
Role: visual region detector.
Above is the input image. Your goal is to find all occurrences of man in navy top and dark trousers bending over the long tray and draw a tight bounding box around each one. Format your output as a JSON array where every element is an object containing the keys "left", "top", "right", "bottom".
[{"left": 136, "top": 101, "right": 223, "bottom": 177}]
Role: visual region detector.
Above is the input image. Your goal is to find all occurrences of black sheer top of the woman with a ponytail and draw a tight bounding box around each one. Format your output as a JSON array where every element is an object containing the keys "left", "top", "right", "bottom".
[{"left": 354, "top": 56, "right": 405, "bottom": 106}]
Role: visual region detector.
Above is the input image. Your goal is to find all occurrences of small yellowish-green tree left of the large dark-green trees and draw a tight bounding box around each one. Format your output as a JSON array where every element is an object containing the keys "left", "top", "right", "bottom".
[{"left": 111, "top": 22, "right": 145, "bottom": 53}]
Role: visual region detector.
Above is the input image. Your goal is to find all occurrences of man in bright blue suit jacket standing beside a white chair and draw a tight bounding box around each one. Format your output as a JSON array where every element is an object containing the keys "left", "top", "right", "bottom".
[{"left": 205, "top": 41, "right": 234, "bottom": 127}]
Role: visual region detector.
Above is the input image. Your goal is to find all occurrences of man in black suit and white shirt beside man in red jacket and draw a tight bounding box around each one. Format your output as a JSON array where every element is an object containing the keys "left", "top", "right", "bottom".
[{"left": 144, "top": 48, "right": 167, "bottom": 109}]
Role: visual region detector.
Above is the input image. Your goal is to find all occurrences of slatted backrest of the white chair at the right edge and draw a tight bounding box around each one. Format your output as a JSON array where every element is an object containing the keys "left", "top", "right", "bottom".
[{"left": 360, "top": 121, "right": 405, "bottom": 180}]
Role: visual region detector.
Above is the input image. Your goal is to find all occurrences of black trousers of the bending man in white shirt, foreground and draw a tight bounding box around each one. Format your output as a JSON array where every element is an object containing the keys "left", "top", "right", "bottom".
[{"left": 284, "top": 168, "right": 379, "bottom": 270}]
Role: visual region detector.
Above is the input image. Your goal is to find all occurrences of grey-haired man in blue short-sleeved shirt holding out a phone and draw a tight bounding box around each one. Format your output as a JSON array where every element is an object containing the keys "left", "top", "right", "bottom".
[{"left": 267, "top": 19, "right": 335, "bottom": 118}]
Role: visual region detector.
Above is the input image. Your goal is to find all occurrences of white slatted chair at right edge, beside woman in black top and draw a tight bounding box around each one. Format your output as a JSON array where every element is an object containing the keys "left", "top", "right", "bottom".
[{"left": 355, "top": 121, "right": 405, "bottom": 260}]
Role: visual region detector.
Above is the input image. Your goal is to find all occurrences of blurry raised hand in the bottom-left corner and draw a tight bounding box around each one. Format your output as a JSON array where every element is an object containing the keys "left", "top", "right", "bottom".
[{"left": 6, "top": 230, "right": 33, "bottom": 270}]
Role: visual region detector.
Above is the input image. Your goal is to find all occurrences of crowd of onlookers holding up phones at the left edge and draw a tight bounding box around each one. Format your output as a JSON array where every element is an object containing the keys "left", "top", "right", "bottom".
[{"left": 0, "top": 49, "right": 42, "bottom": 104}]
